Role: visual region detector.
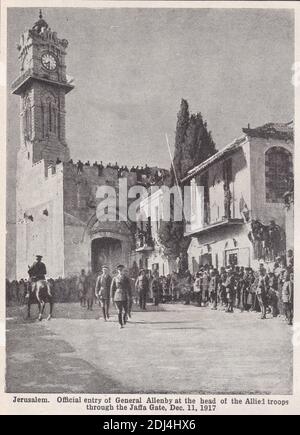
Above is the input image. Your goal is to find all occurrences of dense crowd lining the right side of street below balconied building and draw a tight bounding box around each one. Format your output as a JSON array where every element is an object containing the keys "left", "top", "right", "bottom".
[{"left": 178, "top": 259, "right": 294, "bottom": 325}]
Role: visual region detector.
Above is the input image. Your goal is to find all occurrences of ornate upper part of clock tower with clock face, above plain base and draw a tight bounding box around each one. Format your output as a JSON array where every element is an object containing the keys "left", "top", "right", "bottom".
[{"left": 12, "top": 11, "right": 73, "bottom": 167}]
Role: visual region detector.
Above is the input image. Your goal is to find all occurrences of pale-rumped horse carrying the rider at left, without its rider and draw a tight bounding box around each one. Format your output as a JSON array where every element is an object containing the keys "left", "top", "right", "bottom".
[{"left": 27, "top": 279, "right": 54, "bottom": 321}]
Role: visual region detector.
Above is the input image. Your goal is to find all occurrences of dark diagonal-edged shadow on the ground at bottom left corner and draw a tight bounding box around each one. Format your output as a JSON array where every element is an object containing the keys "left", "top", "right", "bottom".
[{"left": 6, "top": 320, "right": 120, "bottom": 393}]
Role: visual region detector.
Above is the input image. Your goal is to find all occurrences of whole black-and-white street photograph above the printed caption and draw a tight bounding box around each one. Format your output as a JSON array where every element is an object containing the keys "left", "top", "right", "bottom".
[{"left": 3, "top": 2, "right": 300, "bottom": 398}]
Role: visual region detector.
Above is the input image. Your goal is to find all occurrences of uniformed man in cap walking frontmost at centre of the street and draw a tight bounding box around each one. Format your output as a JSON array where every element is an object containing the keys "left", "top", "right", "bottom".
[{"left": 110, "top": 264, "right": 131, "bottom": 328}]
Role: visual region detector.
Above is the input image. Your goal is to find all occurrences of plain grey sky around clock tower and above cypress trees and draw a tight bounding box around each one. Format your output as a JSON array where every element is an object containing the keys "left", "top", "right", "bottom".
[{"left": 7, "top": 8, "right": 294, "bottom": 220}]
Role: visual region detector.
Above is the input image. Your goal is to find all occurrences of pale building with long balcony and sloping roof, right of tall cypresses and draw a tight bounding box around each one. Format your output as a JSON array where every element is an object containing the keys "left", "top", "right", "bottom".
[{"left": 183, "top": 123, "right": 294, "bottom": 272}]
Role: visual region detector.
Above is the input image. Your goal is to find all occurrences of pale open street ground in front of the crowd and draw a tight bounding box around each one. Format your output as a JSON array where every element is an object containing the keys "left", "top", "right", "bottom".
[{"left": 6, "top": 304, "right": 292, "bottom": 394}]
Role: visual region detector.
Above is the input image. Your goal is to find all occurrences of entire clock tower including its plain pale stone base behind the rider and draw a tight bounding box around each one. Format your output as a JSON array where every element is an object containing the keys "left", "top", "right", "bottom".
[{"left": 12, "top": 12, "right": 73, "bottom": 279}]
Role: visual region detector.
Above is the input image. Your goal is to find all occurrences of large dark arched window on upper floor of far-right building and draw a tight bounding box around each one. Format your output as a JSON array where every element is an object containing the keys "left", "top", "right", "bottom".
[{"left": 265, "top": 147, "right": 293, "bottom": 203}]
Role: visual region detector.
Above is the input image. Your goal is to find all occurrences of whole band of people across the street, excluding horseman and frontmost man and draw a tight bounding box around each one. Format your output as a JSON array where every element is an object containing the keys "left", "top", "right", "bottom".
[{"left": 6, "top": 258, "right": 294, "bottom": 325}]
